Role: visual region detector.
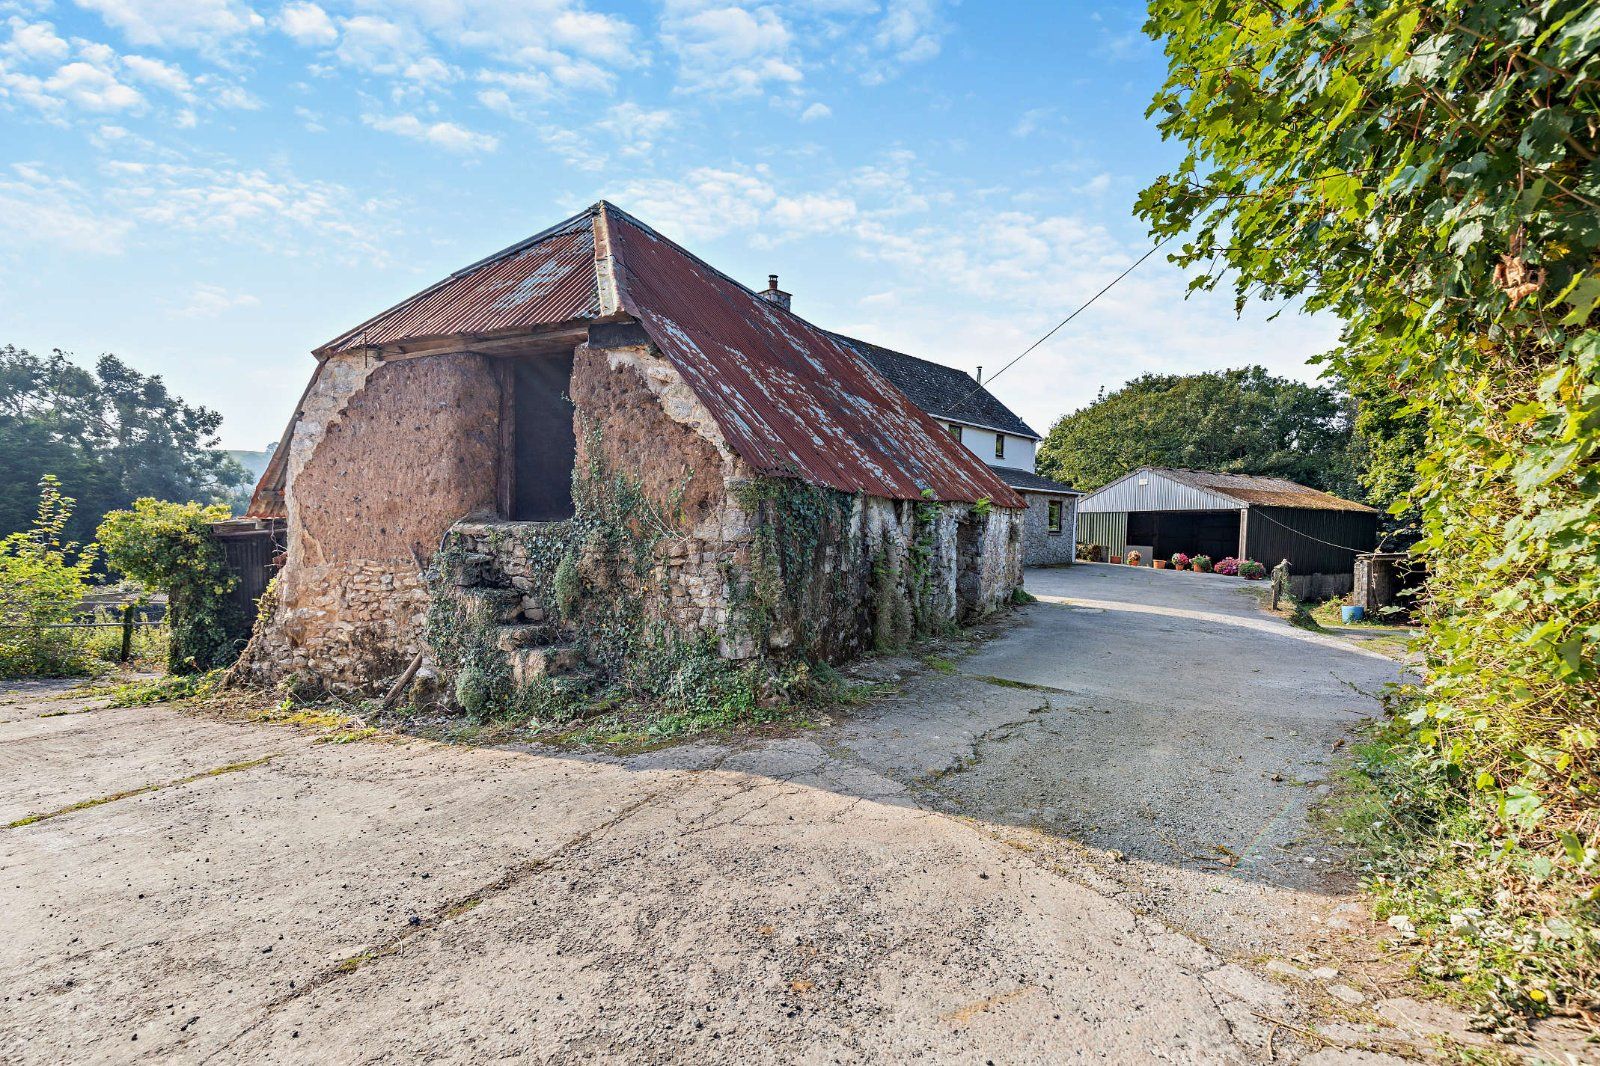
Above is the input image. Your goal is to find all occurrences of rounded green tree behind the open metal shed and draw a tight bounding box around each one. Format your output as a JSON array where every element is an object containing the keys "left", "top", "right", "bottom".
[{"left": 1038, "top": 367, "right": 1360, "bottom": 495}]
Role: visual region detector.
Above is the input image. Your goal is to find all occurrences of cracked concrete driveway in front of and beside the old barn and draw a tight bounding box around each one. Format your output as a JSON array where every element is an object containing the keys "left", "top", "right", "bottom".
[{"left": 0, "top": 567, "right": 1465, "bottom": 1063}]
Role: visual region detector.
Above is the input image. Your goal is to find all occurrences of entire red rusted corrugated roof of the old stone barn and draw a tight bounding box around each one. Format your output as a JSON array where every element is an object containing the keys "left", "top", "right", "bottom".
[{"left": 251, "top": 200, "right": 1026, "bottom": 514}]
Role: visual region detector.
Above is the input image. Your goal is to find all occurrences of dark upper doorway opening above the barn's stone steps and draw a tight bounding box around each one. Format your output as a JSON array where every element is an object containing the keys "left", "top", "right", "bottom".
[{"left": 509, "top": 352, "right": 578, "bottom": 522}]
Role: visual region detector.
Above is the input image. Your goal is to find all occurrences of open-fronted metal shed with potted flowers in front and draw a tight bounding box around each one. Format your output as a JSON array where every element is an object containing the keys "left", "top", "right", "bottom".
[{"left": 1078, "top": 466, "right": 1378, "bottom": 594}]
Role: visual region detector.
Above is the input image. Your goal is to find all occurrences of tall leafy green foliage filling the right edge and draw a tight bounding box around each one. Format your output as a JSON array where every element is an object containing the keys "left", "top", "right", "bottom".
[{"left": 1139, "top": 0, "right": 1600, "bottom": 1010}]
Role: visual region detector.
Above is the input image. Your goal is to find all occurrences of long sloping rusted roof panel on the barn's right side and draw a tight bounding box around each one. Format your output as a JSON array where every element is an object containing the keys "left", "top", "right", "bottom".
[{"left": 605, "top": 205, "right": 1027, "bottom": 507}]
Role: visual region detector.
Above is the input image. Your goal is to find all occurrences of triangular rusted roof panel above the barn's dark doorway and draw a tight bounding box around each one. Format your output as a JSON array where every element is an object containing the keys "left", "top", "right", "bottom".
[{"left": 317, "top": 211, "right": 598, "bottom": 354}]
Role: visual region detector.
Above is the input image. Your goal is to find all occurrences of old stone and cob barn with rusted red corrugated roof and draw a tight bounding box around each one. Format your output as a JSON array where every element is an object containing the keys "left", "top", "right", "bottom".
[{"left": 235, "top": 202, "right": 1026, "bottom": 703}]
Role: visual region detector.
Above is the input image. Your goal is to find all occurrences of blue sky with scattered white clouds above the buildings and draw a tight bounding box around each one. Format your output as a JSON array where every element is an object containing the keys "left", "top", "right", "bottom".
[{"left": 0, "top": 0, "right": 1334, "bottom": 448}]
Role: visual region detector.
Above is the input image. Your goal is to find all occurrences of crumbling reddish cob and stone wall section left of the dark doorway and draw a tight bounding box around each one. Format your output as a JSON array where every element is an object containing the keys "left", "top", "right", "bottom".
[{"left": 238, "top": 354, "right": 499, "bottom": 688}]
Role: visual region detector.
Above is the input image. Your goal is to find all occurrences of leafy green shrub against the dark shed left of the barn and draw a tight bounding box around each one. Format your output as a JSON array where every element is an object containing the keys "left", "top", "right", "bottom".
[{"left": 99, "top": 499, "right": 240, "bottom": 674}]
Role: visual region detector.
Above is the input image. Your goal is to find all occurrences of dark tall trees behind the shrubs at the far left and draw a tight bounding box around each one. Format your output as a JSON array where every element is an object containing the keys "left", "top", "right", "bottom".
[{"left": 0, "top": 344, "right": 248, "bottom": 541}]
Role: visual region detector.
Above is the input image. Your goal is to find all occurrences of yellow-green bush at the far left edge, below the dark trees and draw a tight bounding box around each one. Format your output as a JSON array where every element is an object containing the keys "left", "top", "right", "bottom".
[{"left": 0, "top": 474, "right": 94, "bottom": 677}]
